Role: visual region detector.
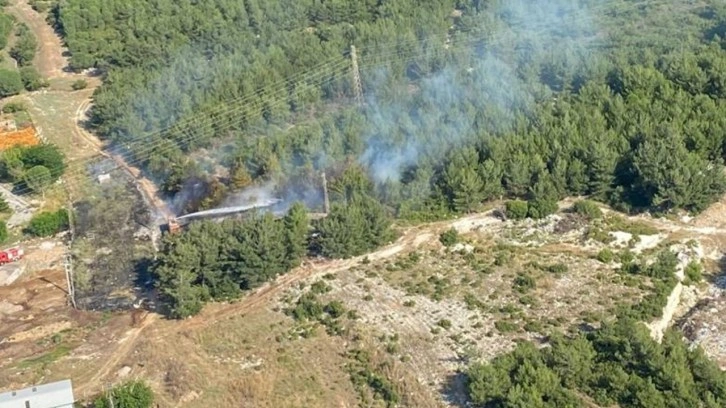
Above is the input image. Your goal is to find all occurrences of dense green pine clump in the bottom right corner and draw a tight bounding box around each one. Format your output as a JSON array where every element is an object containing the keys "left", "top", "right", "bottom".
[{"left": 467, "top": 319, "right": 726, "bottom": 408}]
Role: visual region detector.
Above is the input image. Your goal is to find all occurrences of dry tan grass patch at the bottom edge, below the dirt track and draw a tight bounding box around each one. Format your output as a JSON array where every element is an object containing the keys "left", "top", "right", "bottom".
[{"left": 177, "top": 310, "right": 356, "bottom": 407}]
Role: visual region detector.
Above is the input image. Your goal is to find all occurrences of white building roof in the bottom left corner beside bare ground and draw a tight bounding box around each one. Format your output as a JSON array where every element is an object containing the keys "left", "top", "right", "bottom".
[{"left": 0, "top": 380, "right": 74, "bottom": 408}]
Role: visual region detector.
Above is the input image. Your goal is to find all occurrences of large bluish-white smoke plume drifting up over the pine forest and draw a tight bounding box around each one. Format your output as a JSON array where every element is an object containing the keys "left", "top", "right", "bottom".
[{"left": 359, "top": 0, "right": 597, "bottom": 184}]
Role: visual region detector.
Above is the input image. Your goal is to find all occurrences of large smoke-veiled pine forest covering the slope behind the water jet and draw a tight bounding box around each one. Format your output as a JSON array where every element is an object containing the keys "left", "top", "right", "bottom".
[{"left": 53, "top": 0, "right": 726, "bottom": 218}]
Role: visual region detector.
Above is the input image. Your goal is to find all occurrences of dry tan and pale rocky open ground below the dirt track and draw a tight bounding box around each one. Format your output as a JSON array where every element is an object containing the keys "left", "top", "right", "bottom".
[{"left": 0, "top": 204, "right": 715, "bottom": 407}]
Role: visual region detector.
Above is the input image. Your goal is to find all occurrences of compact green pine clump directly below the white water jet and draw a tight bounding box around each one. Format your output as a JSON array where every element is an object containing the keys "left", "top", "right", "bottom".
[{"left": 154, "top": 205, "right": 309, "bottom": 318}]
